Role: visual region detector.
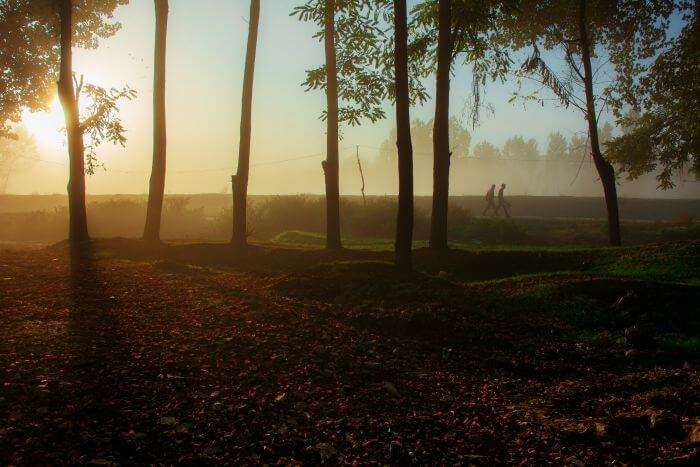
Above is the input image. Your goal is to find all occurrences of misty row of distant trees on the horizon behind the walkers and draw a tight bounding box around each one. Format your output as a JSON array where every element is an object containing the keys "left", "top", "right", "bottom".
[{"left": 341, "top": 118, "right": 695, "bottom": 197}]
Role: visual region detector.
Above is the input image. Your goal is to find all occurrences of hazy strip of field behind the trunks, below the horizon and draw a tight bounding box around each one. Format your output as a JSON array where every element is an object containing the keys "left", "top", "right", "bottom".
[{"left": 0, "top": 195, "right": 700, "bottom": 248}]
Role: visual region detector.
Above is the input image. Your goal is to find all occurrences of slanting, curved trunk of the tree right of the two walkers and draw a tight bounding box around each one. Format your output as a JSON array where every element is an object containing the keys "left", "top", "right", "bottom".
[{"left": 579, "top": 0, "right": 621, "bottom": 246}]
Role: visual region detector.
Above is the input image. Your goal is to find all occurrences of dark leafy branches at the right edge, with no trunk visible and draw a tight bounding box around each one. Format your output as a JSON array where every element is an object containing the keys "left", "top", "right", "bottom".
[{"left": 606, "top": 1, "right": 700, "bottom": 190}]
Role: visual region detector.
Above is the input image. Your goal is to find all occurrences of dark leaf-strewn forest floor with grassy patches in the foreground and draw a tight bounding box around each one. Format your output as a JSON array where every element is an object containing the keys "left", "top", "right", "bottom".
[{"left": 0, "top": 240, "right": 700, "bottom": 465}]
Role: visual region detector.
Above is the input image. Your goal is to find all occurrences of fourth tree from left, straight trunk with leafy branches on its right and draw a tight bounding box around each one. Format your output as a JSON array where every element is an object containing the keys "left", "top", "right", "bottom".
[{"left": 292, "top": 0, "right": 427, "bottom": 248}]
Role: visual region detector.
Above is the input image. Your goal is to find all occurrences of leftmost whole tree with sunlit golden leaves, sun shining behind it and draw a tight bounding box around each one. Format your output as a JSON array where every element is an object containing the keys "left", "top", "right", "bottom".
[{"left": 0, "top": 0, "right": 135, "bottom": 245}]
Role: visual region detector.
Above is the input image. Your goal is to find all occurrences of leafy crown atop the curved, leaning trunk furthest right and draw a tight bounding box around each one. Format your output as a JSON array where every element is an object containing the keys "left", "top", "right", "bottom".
[{"left": 503, "top": 0, "right": 682, "bottom": 120}]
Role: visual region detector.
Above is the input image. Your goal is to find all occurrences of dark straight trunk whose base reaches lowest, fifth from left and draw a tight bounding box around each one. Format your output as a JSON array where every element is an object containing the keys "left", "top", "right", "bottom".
[{"left": 394, "top": 0, "right": 413, "bottom": 272}]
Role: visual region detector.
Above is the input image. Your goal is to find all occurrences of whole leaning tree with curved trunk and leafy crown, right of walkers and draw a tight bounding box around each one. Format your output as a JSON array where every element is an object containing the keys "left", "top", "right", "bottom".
[{"left": 507, "top": 0, "right": 673, "bottom": 245}]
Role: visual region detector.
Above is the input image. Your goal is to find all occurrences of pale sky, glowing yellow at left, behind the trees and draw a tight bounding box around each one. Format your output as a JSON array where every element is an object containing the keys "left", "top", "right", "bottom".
[{"left": 8, "top": 0, "right": 700, "bottom": 198}]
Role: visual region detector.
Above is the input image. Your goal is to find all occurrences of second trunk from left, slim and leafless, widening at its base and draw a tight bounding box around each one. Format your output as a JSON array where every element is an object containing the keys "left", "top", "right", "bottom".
[{"left": 143, "top": 0, "right": 168, "bottom": 242}]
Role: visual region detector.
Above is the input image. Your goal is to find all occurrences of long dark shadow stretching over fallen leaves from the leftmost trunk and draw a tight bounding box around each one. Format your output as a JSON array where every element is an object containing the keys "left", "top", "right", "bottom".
[{"left": 67, "top": 244, "right": 134, "bottom": 460}]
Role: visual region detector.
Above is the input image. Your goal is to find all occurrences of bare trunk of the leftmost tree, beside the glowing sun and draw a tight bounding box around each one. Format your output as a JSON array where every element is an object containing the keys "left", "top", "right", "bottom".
[{"left": 58, "top": 0, "right": 90, "bottom": 242}]
